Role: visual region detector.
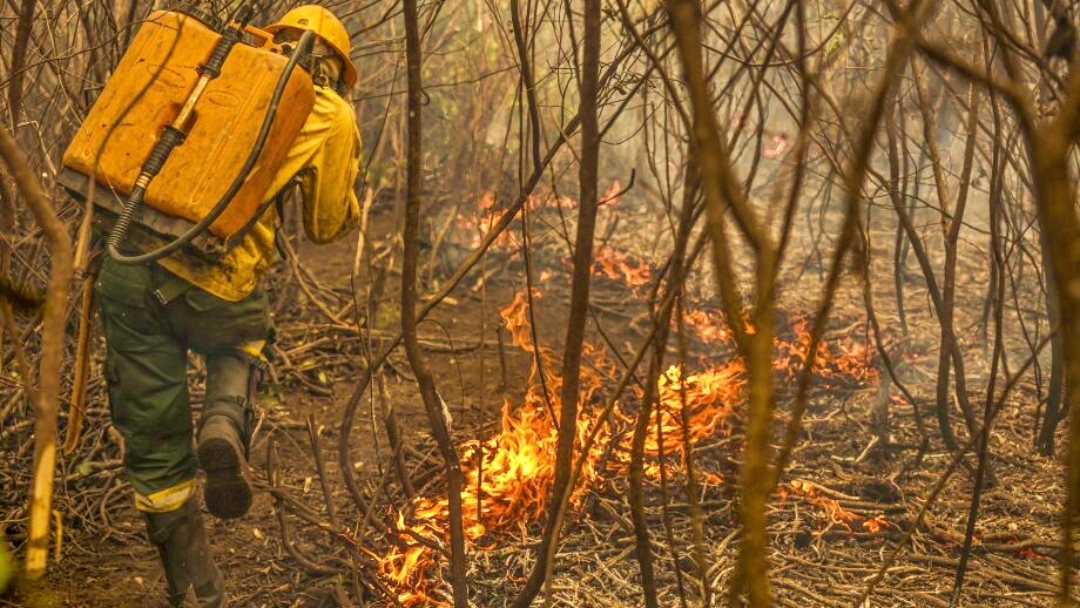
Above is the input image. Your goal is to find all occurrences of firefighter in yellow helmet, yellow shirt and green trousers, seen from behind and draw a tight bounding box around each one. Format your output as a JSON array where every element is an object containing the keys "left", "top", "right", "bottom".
[{"left": 95, "top": 5, "right": 361, "bottom": 607}]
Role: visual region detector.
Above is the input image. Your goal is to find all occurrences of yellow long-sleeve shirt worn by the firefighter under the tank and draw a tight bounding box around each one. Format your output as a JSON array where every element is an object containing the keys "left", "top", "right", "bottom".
[{"left": 145, "top": 86, "right": 361, "bottom": 301}]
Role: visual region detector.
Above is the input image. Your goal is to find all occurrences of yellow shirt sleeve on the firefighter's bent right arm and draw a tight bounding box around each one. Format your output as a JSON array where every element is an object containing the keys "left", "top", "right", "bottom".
[{"left": 271, "top": 86, "right": 361, "bottom": 243}]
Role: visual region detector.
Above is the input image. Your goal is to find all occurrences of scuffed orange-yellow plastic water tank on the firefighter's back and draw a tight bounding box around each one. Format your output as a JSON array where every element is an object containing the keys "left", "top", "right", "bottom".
[{"left": 62, "top": 11, "right": 314, "bottom": 242}]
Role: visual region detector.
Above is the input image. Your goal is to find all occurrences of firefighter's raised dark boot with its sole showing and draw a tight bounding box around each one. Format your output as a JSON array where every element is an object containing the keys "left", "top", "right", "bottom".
[{"left": 199, "top": 354, "right": 252, "bottom": 519}]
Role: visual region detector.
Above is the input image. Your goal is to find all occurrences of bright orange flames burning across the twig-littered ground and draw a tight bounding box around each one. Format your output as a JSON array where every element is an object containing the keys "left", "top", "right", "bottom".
[{"left": 379, "top": 242, "right": 889, "bottom": 607}]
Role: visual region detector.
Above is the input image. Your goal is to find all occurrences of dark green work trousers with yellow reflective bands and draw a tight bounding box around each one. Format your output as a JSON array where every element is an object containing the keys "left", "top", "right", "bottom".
[{"left": 95, "top": 256, "right": 272, "bottom": 512}]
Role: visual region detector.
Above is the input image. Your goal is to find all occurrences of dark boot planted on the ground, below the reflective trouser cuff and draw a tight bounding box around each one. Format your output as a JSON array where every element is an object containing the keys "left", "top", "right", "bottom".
[{"left": 146, "top": 500, "right": 229, "bottom": 608}]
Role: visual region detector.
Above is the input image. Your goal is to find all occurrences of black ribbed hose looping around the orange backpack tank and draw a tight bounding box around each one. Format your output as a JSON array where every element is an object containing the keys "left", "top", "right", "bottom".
[{"left": 108, "top": 30, "right": 315, "bottom": 265}]
